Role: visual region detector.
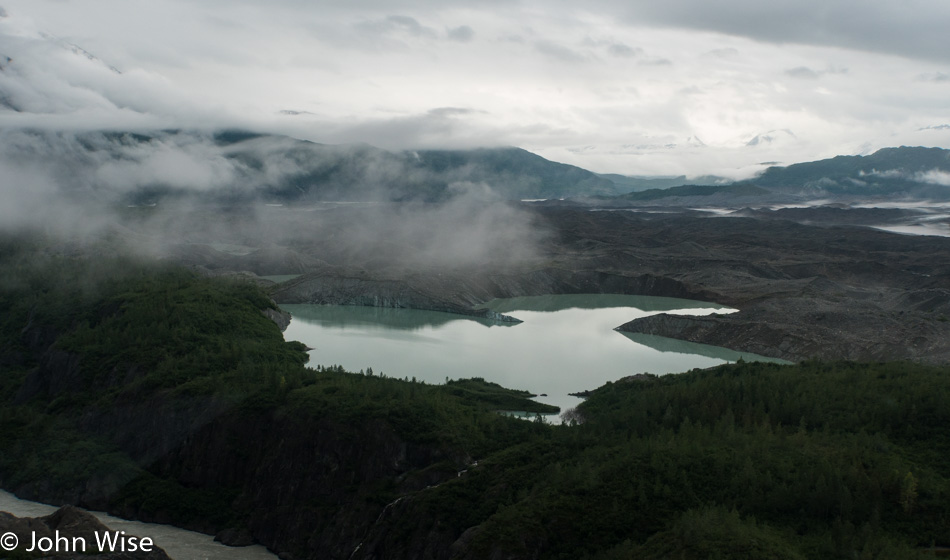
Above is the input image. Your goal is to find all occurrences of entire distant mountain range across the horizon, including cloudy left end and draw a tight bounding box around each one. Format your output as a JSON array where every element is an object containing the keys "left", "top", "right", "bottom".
[{"left": 0, "top": 126, "right": 950, "bottom": 205}]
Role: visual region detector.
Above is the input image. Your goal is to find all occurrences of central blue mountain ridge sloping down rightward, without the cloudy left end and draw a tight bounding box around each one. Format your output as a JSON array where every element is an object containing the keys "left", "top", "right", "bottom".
[{"left": 214, "top": 132, "right": 623, "bottom": 202}]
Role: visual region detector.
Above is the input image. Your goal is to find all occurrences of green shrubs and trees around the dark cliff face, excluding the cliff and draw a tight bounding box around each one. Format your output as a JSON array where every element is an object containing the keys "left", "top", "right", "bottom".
[{"left": 0, "top": 234, "right": 950, "bottom": 560}]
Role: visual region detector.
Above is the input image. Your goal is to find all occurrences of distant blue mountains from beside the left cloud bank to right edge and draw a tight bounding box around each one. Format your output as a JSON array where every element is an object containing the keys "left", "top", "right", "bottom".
[{"left": 214, "top": 137, "right": 950, "bottom": 201}]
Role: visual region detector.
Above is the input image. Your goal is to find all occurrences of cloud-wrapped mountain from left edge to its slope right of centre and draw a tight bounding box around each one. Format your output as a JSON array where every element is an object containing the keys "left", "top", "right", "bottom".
[{"left": 0, "top": 126, "right": 621, "bottom": 210}]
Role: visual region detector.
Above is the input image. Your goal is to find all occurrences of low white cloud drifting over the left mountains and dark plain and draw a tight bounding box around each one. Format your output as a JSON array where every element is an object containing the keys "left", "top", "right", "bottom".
[{"left": 0, "top": 127, "right": 544, "bottom": 267}]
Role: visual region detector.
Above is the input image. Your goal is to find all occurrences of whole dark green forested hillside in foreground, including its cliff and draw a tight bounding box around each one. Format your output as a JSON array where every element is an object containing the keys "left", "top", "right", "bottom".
[{"left": 0, "top": 234, "right": 950, "bottom": 559}]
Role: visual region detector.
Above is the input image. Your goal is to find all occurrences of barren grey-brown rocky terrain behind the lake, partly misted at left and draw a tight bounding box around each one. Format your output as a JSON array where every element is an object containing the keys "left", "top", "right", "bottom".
[{"left": 151, "top": 205, "right": 950, "bottom": 363}]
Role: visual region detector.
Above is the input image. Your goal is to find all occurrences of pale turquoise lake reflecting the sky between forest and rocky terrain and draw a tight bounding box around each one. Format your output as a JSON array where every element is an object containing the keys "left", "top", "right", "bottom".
[{"left": 281, "top": 294, "right": 778, "bottom": 411}]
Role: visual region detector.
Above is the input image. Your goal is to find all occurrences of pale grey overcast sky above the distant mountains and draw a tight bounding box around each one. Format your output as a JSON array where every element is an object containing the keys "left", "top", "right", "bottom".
[{"left": 0, "top": 0, "right": 950, "bottom": 177}]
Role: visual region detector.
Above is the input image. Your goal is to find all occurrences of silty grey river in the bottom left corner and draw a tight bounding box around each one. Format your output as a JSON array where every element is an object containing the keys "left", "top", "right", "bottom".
[{"left": 0, "top": 490, "right": 277, "bottom": 560}]
